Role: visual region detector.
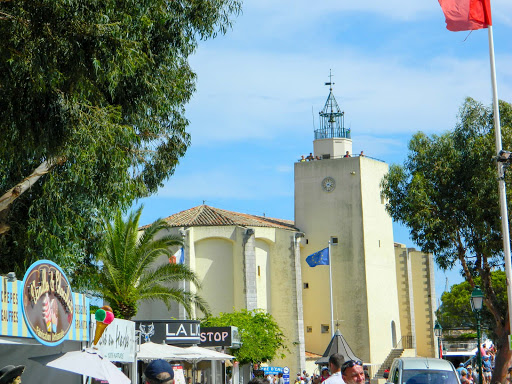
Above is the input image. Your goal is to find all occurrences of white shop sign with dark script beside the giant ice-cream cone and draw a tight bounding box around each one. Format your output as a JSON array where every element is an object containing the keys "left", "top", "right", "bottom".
[{"left": 91, "top": 316, "right": 135, "bottom": 363}]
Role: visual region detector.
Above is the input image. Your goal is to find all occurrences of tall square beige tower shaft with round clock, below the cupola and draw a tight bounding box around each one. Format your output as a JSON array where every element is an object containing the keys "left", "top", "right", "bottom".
[{"left": 295, "top": 157, "right": 400, "bottom": 364}]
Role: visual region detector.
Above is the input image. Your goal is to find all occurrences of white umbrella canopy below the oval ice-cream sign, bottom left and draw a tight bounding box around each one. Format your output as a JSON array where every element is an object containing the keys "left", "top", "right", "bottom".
[{"left": 31, "top": 349, "right": 131, "bottom": 384}]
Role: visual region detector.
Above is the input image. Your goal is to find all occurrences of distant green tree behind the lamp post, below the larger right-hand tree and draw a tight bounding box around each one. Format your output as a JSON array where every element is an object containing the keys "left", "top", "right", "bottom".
[{"left": 436, "top": 271, "right": 507, "bottom": 339}]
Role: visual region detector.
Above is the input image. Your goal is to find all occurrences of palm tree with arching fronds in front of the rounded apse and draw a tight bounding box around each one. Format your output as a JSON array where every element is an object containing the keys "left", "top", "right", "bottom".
[{"left": 98, "top": 207, "right": 209, "bottom": 319}]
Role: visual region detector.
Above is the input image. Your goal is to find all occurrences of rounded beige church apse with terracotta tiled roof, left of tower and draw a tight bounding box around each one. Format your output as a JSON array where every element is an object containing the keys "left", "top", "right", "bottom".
[{"left": 136, "top": 205, "right": 305, "bottom": 371}]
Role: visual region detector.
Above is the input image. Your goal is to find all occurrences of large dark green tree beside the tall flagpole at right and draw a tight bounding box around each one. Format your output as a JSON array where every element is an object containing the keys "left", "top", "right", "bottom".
[{"left": 383, "top": 98, "right": 512, "bottom": 382}]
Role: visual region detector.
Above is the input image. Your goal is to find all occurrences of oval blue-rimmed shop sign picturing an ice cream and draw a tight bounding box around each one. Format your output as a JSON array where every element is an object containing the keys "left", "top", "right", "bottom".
[{"left": 21, "top": 260, "right": 75, "bottom": 346}]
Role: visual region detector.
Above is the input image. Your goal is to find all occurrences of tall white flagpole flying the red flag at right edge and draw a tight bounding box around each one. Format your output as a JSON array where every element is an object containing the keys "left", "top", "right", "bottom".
[{"left": 486, "top": 25, "right": 512, "bottom": 334}]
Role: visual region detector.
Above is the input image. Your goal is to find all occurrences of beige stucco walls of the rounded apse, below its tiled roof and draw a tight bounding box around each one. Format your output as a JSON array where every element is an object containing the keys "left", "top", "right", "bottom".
[{"left": 136, "top": 226, "right": 305, "bottom": 372}]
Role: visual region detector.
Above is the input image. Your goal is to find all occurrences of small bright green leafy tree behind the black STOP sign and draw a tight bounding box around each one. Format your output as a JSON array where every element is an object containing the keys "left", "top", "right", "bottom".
[{"left": 201, "top": 309, "right": 287, "bottom": 365}]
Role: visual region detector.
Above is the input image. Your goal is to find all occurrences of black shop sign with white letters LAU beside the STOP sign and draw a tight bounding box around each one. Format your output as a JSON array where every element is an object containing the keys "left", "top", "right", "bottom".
[{"left": 135, "top": 320, "right": 201, "bottom": 345}]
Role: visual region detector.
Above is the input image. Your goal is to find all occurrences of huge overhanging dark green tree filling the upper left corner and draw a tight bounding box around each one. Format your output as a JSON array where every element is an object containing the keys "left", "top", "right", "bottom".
[{"left": 0, "top": 0, "right": 241, "bottom": 285}]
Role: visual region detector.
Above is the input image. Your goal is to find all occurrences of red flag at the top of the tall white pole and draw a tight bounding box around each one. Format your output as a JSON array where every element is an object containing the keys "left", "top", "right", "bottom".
[{"left": 439, "top": 0, "right": 492, "bottom": 32}]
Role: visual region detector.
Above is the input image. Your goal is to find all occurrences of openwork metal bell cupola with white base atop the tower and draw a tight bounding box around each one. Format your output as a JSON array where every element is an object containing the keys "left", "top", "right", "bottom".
[{"left": 313, "top": 71, "right": 352, "bottom": 159}]
